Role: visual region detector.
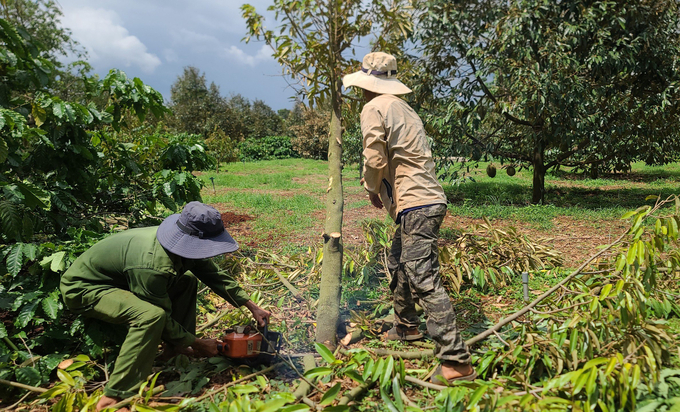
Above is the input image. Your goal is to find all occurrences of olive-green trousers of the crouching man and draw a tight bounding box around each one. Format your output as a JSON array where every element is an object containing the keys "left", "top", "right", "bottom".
[{"left": 83, "top": 273, "right": 198, "bottom": 398}]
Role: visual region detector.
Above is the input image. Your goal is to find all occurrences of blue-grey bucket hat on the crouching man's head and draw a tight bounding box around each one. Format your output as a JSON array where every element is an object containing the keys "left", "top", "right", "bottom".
[{"left": 156, "top": 202, "right": 238, "bottom": 259}]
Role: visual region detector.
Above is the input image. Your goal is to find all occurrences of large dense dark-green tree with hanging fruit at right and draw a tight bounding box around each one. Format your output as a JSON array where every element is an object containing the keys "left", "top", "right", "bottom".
[{"left": 418, "top": 0, "right": 680, "bottom": 203}]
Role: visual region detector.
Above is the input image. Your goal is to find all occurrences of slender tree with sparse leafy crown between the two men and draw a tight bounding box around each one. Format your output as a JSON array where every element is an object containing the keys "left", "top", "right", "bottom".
[{"left": 241, "top": 0, "right": 411, "bottom": 346}]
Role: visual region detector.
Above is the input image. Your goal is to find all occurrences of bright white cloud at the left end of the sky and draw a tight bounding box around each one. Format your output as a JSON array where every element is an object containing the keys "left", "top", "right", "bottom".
[{"left": 62, "top": 7, "right": 161, "bottom": 73}]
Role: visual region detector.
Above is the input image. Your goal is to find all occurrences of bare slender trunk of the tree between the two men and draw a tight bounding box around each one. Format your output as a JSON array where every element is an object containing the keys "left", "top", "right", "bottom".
[{"left": 316, "top": 83, "right": 343, "bottom": 349}]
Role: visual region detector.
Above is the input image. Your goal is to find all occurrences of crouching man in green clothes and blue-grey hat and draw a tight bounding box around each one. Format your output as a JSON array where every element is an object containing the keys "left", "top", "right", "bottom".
[{"left": 61, "top": 202, "right": 271, "bottom": 411}]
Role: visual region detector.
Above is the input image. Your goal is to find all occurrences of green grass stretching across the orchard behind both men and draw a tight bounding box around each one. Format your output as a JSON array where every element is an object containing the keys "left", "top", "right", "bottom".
[{"left": 201, "top": 159, "right": 680, "bottom": 258}]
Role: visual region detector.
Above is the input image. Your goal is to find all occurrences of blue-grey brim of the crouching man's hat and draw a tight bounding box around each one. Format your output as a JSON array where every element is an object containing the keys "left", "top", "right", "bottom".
[{"left": 156, "top": 214, "right": 238, "bottom": 259}]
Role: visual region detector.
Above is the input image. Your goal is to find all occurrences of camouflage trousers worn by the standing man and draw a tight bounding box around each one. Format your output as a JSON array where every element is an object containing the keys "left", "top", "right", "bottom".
[{"left": 388, "top": 205, "right": 470, "bottom": 363}]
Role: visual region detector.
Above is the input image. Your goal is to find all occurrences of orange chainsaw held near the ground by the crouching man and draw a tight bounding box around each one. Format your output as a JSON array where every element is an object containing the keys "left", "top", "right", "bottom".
[{"left": 217, "top": 323, "right": 282, "bottom": 364}]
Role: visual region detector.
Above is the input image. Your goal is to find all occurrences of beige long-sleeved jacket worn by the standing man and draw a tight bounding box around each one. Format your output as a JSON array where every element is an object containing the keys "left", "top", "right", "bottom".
[{"left": 361, "top": 94, "right": 446, "bottom": 221}]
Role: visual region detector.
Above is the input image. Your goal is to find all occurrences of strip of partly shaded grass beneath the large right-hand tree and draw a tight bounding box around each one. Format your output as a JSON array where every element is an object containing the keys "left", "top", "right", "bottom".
[{"left": 445, "top": 163, "right": 680, "bottom": 230}]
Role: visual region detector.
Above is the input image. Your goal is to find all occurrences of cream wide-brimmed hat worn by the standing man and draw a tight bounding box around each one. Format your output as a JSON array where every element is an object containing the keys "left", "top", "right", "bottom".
[{"left": 342, "top": 52, "right": 411, "bottom": 95}]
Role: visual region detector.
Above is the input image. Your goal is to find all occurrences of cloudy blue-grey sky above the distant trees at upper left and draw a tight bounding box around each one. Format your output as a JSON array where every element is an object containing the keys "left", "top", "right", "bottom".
[{"left": 58, "top": 0, "right": 295, "bottom": 110}]
